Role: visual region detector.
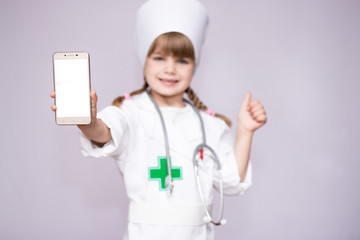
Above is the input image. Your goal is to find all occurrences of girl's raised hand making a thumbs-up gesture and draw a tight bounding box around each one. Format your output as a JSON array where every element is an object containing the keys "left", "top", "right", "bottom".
[{"left": 238, "top": 92, "right": 267, "bottom": 132}]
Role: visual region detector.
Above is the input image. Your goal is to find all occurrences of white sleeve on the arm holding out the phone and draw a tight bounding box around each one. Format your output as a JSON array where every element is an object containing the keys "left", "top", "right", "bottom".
[{"left": 80, "top": 106, "right": 130, "bottom": 157}]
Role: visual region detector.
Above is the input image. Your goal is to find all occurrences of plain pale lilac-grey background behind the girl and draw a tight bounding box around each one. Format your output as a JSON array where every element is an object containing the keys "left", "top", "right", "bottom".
[{"left": 0, "top": 0, "right": 360, "bottom": 240}]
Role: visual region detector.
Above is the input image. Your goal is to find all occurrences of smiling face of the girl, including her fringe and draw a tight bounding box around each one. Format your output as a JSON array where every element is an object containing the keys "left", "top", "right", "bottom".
[{"left": 144, "top": 33, "right": 195, "bottom": 107}]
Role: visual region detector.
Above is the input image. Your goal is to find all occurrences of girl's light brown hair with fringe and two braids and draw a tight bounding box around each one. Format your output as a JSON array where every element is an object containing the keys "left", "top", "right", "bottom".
[{"left": 112, "top": 32, "right": 231, "bottom": 127}]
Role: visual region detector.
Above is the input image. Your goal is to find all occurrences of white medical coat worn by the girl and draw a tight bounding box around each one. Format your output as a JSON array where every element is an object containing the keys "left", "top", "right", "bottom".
[{"left": 80, "top": 92, "right": 251, "bottom": 240}]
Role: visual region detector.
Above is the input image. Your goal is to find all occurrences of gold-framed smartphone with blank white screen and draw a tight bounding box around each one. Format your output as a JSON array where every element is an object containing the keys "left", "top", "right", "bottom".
[{"left": 53, "top": 52, "right": 91, "bottom": 125}]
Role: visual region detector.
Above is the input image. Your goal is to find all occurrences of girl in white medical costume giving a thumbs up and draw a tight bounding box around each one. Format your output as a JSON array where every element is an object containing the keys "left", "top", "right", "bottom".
[{"left": 51, "top": 0, "right": 266, "bottom": 240}]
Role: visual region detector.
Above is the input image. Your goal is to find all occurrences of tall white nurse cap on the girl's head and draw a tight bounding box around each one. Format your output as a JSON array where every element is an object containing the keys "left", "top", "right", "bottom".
[{"left": 135, "top": 0, "right": 208, "bottom": 67}]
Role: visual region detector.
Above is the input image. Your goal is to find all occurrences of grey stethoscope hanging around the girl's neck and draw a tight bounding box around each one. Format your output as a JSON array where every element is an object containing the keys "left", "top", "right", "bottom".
[{"left": 146, "top": 91, "right": 226, "bottom": 226}]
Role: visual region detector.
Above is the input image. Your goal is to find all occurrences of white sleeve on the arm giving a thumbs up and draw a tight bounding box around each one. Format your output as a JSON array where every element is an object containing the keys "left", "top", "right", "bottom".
[{"left": 214, "top": 126, "right": 252, "bottom": 195}]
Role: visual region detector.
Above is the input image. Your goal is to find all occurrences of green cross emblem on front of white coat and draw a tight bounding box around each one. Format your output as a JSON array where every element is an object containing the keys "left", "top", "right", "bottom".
[{"left": 149, "top": 157, "right": 182, "bottom": 191}]
